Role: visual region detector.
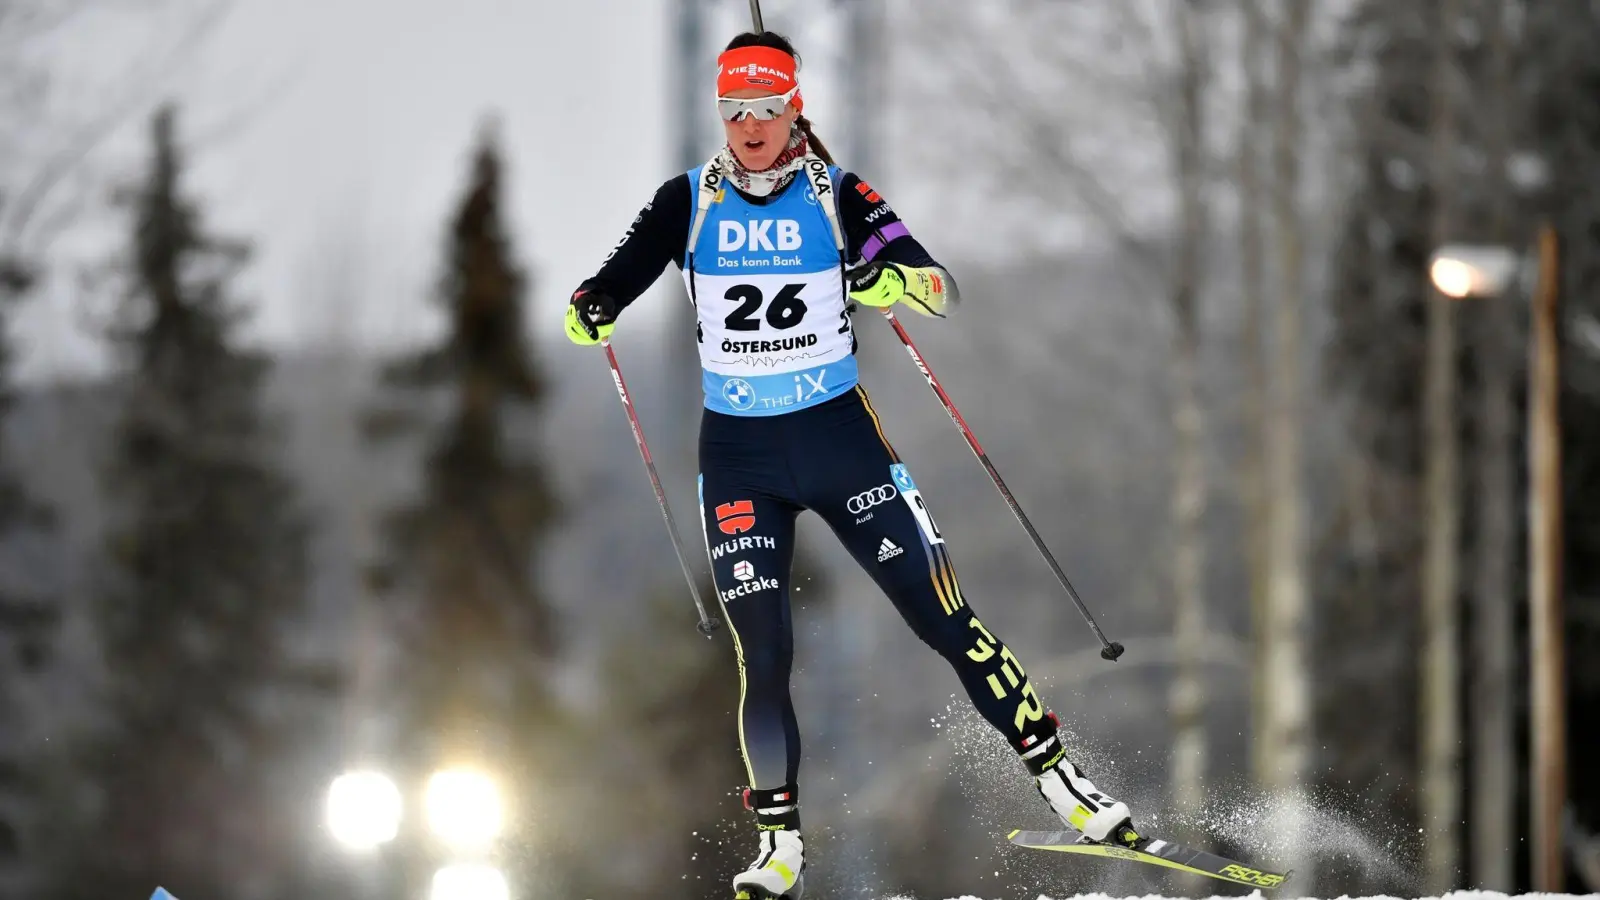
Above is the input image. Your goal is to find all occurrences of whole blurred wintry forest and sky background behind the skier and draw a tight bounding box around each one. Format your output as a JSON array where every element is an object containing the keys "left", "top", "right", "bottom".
[{"left": 0, "top": 0, "right": 1600, "bottom": 900}]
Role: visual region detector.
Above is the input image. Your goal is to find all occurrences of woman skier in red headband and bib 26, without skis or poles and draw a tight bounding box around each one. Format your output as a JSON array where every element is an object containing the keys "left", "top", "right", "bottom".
[{"left": 565, "top": 32, "right": 1138, "bottom": 900}]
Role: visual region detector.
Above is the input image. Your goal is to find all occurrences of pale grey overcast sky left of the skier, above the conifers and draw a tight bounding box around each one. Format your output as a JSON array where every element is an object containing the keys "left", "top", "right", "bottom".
[{"left": 19, "top": 0, "right": 694, "bottom": 373}]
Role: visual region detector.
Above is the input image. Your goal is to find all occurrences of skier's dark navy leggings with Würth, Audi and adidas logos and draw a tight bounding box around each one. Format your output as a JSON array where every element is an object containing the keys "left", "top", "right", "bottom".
[{"left": 699, "top": 388, "right": 1054, "bottom": 790}]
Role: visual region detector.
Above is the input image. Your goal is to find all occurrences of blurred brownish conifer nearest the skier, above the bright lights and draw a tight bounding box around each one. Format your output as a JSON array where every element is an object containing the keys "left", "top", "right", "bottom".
[{"left": 368, "top": 119, "right": 566, "bottom": 878}]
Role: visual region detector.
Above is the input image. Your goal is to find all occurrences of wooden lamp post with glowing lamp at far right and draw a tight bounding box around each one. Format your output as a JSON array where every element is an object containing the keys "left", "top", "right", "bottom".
[{"left": 1429, "top": 224, "right": 1566, "bottom": 894}]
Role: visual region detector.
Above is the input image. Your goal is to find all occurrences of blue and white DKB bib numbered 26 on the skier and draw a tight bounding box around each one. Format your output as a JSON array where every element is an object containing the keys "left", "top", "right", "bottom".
[{"left": 683, "top": 162, "right": 858, "bottom": 416}]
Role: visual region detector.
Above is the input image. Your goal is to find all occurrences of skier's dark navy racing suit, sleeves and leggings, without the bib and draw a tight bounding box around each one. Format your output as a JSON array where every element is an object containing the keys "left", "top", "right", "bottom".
[{"left": 579, "top": 173, "right": 1061, "bottom": 828}]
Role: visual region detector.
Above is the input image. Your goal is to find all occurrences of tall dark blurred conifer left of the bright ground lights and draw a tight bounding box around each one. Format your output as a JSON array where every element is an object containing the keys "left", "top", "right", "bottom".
[{"left": 56, "top": 107, "right": 331, "bottom": 897}]
